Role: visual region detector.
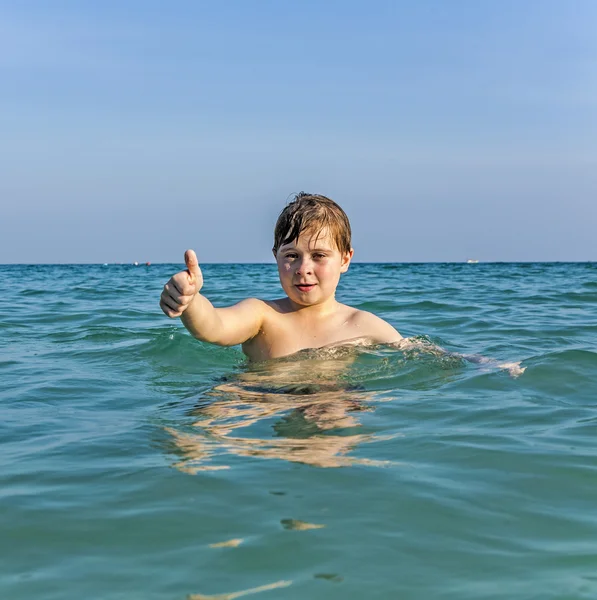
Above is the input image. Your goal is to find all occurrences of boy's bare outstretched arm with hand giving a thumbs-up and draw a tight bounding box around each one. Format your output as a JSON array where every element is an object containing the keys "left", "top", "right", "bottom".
[{"left": 160, "top": 250, "right": 265, "bottom": 346}]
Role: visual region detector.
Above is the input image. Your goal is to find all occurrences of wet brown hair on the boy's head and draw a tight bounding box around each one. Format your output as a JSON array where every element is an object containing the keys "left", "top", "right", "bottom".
[{"left": 273, "top": 192, "right": 352, "bottom": 254}]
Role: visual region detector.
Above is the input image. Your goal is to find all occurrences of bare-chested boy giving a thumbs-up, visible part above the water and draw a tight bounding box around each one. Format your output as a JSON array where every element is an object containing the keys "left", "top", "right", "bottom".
[{"left": 160, "top": 192, "right": 402, "bottom": 361}]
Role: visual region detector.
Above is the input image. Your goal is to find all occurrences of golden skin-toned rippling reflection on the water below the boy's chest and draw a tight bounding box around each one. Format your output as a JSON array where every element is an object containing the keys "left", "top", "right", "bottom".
[{"left": 168, "top": 347, "right": 395, "bottom": 474}]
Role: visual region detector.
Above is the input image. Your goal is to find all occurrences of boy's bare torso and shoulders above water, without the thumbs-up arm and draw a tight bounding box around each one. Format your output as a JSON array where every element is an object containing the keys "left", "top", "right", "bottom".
[{"left": 242, "top": 298, "right": 401, "bottom": 361}]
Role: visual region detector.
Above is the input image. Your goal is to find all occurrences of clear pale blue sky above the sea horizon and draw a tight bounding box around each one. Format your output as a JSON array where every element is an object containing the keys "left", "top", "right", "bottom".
[{"left": 0, "top": 0, "right": 597, "bottom": 264}]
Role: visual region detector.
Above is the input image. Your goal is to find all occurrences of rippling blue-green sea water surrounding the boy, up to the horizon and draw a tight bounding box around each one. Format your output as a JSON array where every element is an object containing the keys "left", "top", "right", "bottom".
[{"left": 0, "top": 263, "right": 597, "bottom": 600}]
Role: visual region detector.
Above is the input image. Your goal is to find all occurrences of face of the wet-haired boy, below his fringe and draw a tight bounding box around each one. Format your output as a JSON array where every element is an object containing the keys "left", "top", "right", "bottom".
[{"left": 275, "top": 229, "right": 353, "bottom": 306}]
